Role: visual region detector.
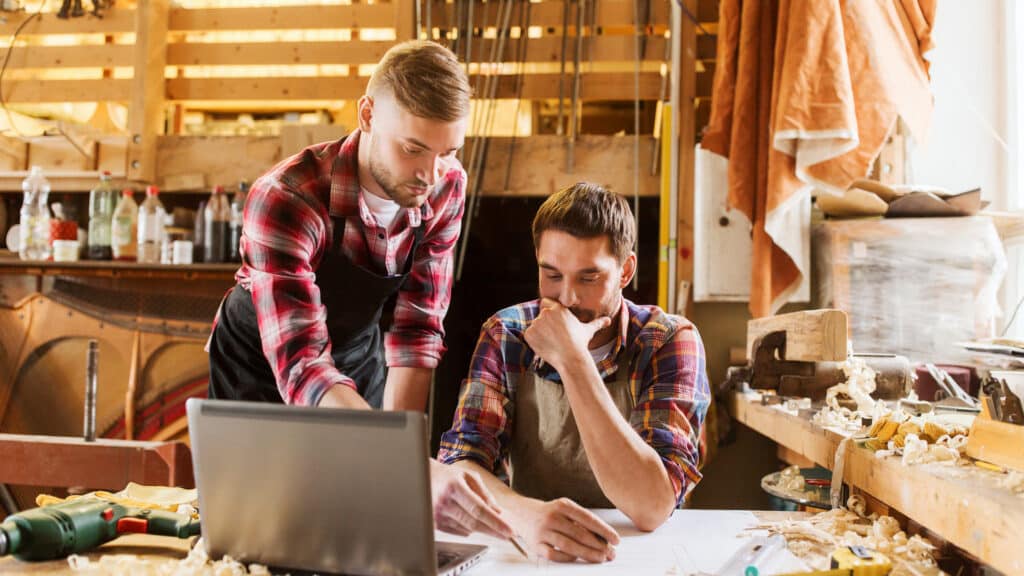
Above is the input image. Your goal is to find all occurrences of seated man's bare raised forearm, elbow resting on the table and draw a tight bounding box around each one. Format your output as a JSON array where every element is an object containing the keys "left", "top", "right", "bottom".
[{"left": 559, "top": 358, "right": 676, "bottom": 530}]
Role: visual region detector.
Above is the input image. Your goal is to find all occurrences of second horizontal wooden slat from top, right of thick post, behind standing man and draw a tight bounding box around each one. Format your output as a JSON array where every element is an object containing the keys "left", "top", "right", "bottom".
[{"left": 164, "top": 36, "right": 666, "bottom": 66}]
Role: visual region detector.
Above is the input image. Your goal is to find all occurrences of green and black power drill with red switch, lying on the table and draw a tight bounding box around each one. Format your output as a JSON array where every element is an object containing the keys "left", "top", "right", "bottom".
[{"left": 0, "top": 497, "right": 200, "bottom": 561}]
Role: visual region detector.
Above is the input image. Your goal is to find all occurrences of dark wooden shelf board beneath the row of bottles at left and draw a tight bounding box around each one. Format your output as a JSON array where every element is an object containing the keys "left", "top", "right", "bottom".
[{"left": 0, "top": 251, "right": 235, "bottom": 280}]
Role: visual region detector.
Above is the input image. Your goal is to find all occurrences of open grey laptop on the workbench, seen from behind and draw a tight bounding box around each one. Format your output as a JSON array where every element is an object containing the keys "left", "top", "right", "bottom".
[{"left": 186, "top": 398, "right": 486, "bottom": 576}]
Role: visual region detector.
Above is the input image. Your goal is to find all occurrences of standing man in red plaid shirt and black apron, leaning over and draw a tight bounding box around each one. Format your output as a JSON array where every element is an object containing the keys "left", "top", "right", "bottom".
[{"left": 208, "top": 41, "right": 511, "bottom": 537}]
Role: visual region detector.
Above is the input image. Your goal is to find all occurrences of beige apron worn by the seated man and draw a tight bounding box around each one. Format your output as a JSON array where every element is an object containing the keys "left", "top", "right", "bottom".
[{"left": 509, "top": 346, "right": 639, "bottom": 508}]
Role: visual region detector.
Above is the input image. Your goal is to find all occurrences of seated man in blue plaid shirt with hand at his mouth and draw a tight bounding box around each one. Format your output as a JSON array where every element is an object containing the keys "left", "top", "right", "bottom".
[{"left": 437, "top": 183, "right": 711, "bottom": 562}]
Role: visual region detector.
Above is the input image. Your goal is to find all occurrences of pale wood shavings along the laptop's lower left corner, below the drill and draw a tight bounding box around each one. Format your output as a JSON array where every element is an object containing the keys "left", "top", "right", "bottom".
[{"left": 68, "top": 539, "right": 270, "bottom": 576}]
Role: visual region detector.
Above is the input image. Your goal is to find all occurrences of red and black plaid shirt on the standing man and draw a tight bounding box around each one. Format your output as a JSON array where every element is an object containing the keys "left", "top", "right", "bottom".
[{"left": 226, "top": 130, "right": 466, "bottom": 406}]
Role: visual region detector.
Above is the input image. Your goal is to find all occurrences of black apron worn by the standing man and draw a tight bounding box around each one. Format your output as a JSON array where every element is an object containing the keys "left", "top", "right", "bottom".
[{"left": 209, "top": 193, "right": 423, "bottom": 408}]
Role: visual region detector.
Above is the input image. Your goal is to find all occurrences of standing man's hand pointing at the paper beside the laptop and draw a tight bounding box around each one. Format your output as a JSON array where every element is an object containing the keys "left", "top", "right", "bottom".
[{"left": 430, "top": 459, "right": 513, "bottom": 540}]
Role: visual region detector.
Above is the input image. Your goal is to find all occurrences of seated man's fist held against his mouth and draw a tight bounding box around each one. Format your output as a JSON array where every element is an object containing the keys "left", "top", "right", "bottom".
[{"left": 522, "top": 298, "right": 611, "bottom": 370}]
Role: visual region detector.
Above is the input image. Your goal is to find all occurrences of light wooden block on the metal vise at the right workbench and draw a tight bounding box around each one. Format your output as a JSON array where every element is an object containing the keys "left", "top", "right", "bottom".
[{"left": 746, "top": 310, "right": 847, "bottom": 362}]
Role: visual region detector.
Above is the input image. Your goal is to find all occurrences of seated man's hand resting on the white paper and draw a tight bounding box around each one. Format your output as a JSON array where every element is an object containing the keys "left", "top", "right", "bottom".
[{"left": 510, "top": 498, "right": 618, "bottom": 563}]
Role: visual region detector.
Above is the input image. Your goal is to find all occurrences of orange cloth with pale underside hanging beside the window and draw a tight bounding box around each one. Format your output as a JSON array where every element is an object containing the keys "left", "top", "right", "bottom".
[{"left": 701, "top": 0, "right": 936, "bottom": 318}]
